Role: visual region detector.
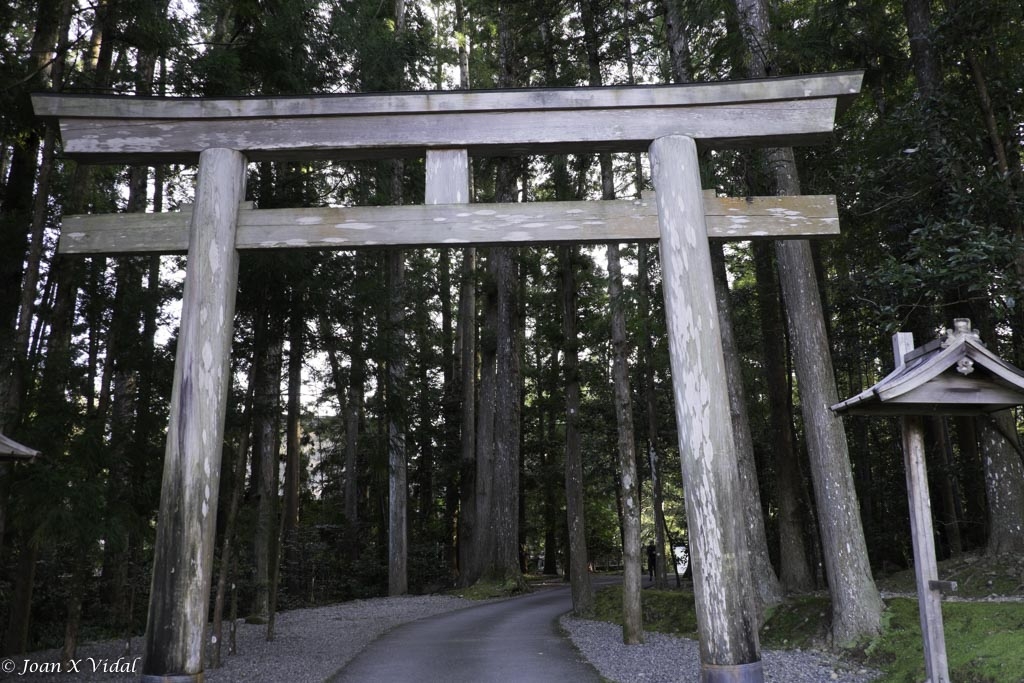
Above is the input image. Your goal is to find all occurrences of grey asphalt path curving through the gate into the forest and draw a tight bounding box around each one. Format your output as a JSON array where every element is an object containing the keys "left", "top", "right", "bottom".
[{"left": 332, "top": 587, "right": 600, "bottom": 683}]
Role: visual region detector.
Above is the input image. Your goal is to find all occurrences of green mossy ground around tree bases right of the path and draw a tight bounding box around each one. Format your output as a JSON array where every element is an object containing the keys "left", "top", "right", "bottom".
[{"left": 596, "top": 557, "right": 1024, "bottom": 683}]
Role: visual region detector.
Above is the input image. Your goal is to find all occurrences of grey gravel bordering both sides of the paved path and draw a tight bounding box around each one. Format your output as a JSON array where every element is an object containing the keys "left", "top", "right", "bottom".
[{"left": 8, "top": 595, "right": 877, "bottom": 683}]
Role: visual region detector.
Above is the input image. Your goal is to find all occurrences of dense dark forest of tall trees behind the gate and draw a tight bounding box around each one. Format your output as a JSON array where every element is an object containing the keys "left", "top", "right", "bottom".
[{"left": 0, "top": 0, "right": 1024, "bottom": 663}]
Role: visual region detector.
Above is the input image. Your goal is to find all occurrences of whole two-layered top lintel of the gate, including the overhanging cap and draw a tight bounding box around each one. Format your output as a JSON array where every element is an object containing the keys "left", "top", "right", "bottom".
[{"left": 33, "top": 72, "right": 862, "bottom": 163}]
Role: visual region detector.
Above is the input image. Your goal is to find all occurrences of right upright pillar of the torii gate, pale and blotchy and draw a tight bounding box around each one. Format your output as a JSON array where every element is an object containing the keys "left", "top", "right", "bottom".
[{"left": 650, "top": 136, "right": 764, "bottom": 682}]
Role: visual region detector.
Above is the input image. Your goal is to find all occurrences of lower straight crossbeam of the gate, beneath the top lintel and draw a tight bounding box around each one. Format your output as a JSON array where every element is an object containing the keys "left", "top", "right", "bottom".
[{"left": 59, "top": 193, "right": 839, "bottom": 254}]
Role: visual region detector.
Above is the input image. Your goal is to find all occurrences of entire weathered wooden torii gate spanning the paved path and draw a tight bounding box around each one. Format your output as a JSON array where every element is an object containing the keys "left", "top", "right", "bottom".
[{"left": 33, "top": 72, "right": 863, "bottom": 683}]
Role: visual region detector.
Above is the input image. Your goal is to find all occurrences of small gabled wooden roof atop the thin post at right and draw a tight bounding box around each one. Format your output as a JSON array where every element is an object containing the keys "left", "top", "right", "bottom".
[{"left": 831, "top": 333, "right": 1024, "bottom": 415}]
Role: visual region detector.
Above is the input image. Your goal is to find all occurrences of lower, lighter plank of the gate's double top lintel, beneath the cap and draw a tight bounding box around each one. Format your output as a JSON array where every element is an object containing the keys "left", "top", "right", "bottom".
[{"left": 39, "top": 97, "right": 837, "bottom": 164}]
